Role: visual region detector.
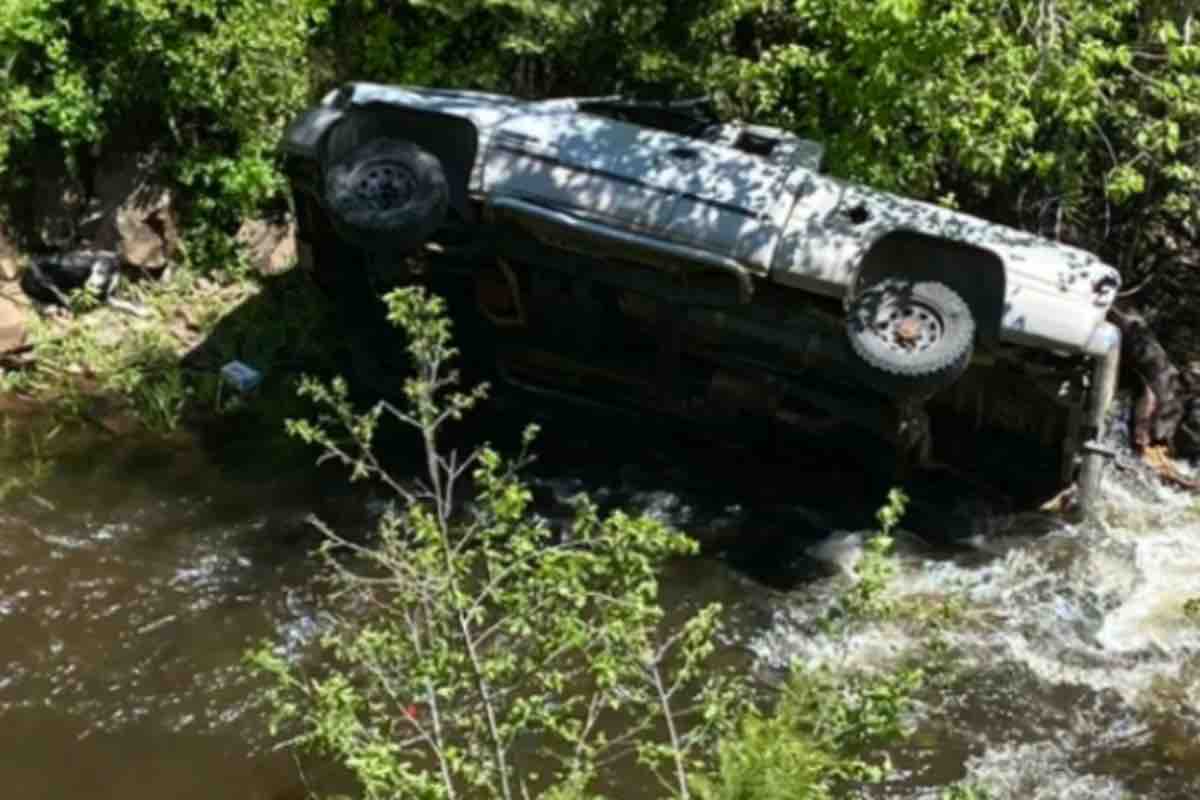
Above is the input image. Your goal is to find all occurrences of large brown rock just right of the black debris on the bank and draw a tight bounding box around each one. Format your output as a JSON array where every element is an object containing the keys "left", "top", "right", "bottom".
[{"left": 92, "top": 152, "right": 179, "bottom": 272}]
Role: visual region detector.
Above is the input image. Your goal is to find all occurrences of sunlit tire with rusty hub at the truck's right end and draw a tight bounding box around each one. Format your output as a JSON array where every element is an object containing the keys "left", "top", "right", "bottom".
[{"left": 846, "top": 278, "right": 976, "bottom": 396}]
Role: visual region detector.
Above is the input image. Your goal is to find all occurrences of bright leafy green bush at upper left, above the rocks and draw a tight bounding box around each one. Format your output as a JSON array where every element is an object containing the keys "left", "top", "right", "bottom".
[{"left": 0, "top": 0, "right": 330, "bottom": 221}]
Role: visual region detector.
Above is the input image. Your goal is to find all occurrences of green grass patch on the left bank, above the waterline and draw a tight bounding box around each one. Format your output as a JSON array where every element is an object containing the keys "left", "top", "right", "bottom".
[{"left": 0, "top": 262, "right": 338, "bottom": 435}]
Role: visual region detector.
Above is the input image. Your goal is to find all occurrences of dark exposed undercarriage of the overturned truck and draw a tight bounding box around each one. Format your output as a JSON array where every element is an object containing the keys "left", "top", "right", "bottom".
[{"left": 297, "top": 203, "right": 1096, "bottom": 510}]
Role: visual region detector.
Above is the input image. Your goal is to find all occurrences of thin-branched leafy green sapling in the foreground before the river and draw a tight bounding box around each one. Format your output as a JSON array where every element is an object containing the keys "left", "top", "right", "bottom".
[{"left": 253, "top": 288, "right": 739, "bottom": 800}]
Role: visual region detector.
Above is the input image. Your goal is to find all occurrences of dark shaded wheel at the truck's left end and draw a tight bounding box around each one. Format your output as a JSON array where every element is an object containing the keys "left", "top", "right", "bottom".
[{"left": 324, "top": 139, "right": 450, "bottom": 253}]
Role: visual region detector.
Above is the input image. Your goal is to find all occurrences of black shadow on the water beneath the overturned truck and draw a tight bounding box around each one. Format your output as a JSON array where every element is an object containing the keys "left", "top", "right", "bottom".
[{"left": 185, "top": 270, "right": 1052, "bottom": 588}]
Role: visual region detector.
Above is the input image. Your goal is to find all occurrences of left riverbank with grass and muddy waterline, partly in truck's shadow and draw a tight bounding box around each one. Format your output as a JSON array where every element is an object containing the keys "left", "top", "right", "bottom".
[{"left": 0, "top": 248, "right": 352, "bottom": 506}]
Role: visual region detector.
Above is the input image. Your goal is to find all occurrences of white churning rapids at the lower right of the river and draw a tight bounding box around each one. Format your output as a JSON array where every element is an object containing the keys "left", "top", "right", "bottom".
[{"left": 751, "top": 459, "right": 1200, "bottom": 800}]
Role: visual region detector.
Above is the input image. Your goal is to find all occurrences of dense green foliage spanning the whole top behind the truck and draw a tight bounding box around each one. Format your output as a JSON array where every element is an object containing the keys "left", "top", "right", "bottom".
[{"left": 0, "top": 0, "right": 1200, "bottom": 326}]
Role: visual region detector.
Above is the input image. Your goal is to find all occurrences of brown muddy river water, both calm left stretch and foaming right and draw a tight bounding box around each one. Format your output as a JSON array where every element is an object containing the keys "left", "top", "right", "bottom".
[{"left": 0, "top": 395, "right": 1200, "bottom": 800}]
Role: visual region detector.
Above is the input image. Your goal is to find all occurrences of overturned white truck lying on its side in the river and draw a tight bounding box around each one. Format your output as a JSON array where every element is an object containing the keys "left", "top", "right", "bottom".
[{"left": 282, "top": 83, "right": 1121, "bottom": 509}]
